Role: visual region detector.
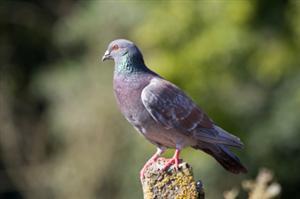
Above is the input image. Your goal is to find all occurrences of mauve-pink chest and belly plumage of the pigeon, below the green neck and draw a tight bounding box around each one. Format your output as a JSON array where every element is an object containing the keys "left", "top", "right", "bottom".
[{"left": 114, "top": 74, "right": 195, "bottom": 148}]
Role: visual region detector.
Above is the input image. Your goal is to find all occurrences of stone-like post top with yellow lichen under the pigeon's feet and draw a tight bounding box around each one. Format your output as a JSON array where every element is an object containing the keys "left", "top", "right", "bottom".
[{"left": 142, "top": 158, "right": 204, "bottom": 199}]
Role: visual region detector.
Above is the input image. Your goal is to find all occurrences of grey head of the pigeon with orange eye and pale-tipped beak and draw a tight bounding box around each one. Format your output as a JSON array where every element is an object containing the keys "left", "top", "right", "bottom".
[{"left": 102, "top": 39, "right": 144, "bottom": 69}]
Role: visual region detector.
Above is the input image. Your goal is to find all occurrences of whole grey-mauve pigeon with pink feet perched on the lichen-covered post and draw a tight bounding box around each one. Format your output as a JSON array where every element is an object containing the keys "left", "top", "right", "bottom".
[{"left": 102, "top": 39, "right": 247, "bottom": 179}]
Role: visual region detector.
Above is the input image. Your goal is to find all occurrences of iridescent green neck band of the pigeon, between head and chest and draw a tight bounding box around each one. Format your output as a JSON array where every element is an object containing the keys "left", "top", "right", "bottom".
[{"left": 115, "top": 54, "right": 149, "bottom": 73}]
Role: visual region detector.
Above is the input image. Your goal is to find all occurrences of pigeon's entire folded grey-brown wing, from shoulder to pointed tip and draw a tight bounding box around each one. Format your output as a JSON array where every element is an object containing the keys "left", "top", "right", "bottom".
[{"left": 141, "top": 78, "right": 243, "bottom": 148}]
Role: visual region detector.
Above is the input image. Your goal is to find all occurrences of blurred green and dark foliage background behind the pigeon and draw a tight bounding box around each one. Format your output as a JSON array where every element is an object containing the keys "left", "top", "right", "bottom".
[{"left": 0, "top": 0, "right": 300, "bottom": 199}]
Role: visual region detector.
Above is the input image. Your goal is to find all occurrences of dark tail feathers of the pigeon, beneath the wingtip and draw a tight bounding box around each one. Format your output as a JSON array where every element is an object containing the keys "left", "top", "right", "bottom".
[{"left": 193, "top": 142, "right": 247, "bottom": 174}]
